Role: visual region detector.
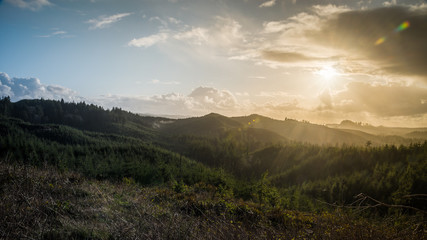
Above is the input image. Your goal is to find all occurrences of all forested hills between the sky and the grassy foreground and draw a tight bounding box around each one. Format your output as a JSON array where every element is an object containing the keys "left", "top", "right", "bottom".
[{"left": 0, "top": 97, "right": 427, "bottom": 239}]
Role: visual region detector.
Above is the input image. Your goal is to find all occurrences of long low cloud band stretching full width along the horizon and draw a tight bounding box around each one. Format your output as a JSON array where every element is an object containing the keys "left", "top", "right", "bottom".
[{"left": 0, "top": 73, "right": 427, "bottom": 126}]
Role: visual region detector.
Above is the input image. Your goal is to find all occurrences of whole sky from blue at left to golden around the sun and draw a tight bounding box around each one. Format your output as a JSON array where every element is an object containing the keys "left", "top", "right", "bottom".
[{"left": 0, "top": 0, "right": 427, "bottom": 127}]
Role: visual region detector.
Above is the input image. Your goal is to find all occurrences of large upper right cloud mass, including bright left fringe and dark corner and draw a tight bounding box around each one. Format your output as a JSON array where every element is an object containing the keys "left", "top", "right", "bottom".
[{"left": 249, "top": 4, "right": 427, "bottom": 81}]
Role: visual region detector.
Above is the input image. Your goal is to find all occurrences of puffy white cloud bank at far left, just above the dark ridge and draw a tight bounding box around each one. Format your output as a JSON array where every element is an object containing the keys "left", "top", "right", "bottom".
[{"left": 0, "top": 72, "right": 78, "bottom": 101}]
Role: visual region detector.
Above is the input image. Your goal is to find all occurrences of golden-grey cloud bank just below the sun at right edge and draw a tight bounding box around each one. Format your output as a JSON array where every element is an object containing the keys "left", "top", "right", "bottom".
[{"left": 333, "top": 82, "right": 427, "bottom": 117}]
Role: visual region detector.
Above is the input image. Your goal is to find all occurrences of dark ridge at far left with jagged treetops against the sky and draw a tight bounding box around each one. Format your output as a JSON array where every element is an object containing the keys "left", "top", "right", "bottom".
[{"left": 0, "top": 97, "right": 159, "bottom": 138}]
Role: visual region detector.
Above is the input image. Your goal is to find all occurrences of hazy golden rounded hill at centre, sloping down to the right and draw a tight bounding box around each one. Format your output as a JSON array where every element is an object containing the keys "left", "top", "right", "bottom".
[{"left": 162, "top": 113, "right": 367, "bottom": 144}]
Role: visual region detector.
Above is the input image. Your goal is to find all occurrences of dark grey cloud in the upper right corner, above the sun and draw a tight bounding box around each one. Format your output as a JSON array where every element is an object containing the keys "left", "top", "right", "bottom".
[{"left": 308, "top": 6, "right": 427, "bottom": 76}]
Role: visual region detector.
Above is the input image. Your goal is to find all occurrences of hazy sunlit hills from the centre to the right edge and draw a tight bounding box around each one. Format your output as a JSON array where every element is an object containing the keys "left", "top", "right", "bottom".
[{"left": 159, "top": 113, "right": 427, "bottom": 145}]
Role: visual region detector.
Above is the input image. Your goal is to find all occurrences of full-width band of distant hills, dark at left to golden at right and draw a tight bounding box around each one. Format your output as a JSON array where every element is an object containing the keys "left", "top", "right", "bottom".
[{"left": 0, "top": 98, "right": 427, "bottom": 147}]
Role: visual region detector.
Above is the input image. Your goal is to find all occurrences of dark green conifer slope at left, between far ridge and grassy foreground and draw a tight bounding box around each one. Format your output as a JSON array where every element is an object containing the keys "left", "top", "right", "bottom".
[{"left": 0, "top": 117, "right": 231, "bottom": 185}]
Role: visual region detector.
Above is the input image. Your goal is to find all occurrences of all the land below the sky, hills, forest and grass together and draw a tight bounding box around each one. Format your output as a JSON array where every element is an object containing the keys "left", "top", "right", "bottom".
[{"left": 0, "top": 98, "right": 427, "bottom": 239}]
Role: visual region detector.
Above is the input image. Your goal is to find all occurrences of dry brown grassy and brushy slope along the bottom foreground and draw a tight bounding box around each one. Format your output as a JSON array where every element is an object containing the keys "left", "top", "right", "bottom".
[{"left": 0, "top": 161, "right": 426, "bottom": 239}]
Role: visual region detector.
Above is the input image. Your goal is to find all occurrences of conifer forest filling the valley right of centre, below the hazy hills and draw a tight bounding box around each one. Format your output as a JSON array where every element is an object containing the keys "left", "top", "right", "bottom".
[{"left": 160, "top": 136, "right": 427, "bottom": 213}]
